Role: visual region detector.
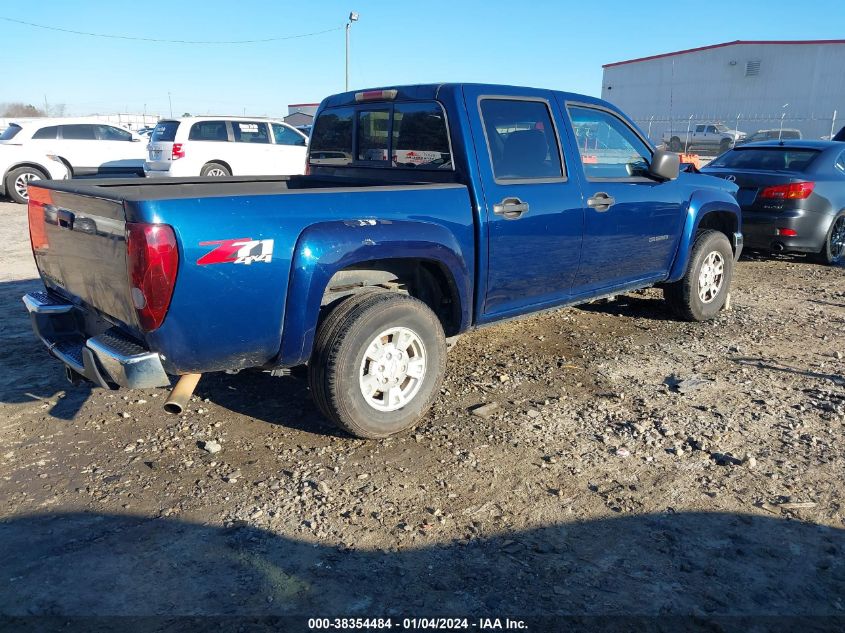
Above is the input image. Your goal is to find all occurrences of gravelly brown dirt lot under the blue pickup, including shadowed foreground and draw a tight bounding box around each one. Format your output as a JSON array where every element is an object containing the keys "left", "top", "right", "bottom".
[{"left": 0, "top": 204, "right": 845, "bottom": 630}]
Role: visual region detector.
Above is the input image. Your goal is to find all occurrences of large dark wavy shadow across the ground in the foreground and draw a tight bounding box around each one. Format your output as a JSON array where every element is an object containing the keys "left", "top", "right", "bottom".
[{"left": 0, "top": 513, "right": 845, "bottom": 631}]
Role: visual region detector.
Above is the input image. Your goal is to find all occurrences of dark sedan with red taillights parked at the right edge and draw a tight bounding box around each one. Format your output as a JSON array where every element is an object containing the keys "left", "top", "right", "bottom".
[{"left": 701, "top": 140, "right": 845, "bottom": 264}]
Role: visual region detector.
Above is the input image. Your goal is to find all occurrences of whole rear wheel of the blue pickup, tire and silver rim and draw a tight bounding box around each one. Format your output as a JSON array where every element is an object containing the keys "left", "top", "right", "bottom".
[{"left": 308, "top": 292, "right": 446, "bottom": 438}]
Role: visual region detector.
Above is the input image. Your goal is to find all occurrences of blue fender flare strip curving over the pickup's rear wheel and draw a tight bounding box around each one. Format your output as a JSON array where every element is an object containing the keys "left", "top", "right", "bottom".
[{"left": 277, "top": 219, "right": 472, "bottom": 367}]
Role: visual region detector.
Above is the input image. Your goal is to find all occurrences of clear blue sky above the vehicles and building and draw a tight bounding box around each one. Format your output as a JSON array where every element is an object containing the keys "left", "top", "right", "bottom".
[{"left": 6, "top": 0, "right": 845, "bottom": 115}]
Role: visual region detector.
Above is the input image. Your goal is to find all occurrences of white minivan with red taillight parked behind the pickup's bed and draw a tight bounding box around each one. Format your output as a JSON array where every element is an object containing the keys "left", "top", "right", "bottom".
[{"left": 144, "top": 117, "right": 308, "bottom": 177}]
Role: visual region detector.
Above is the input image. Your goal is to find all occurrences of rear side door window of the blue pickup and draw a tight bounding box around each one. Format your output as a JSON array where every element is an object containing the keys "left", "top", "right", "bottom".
[{"left": 481, "top": 99, "right": 564, "bottom": 181}]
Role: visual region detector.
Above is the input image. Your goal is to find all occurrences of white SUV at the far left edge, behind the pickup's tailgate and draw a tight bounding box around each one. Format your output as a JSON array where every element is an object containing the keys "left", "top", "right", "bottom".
[{"left": 0, "top": 118, "right": 146, "bottom": 176}]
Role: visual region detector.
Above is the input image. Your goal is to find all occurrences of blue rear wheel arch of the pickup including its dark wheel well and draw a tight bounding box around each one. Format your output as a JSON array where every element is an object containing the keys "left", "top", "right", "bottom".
[{"left": 278, "top": 220, "right": 472, "bottom": 366}]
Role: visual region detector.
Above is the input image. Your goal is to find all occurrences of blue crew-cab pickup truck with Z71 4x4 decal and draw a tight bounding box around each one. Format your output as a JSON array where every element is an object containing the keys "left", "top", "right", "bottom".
[{"left": 24, "top": 84, "right": 742, "bottom": 438}]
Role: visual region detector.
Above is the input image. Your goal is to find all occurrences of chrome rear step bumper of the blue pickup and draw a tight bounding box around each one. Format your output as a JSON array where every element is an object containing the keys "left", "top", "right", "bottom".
[{"left": 23, "top": 292, "right": 170, "bottom": 389}]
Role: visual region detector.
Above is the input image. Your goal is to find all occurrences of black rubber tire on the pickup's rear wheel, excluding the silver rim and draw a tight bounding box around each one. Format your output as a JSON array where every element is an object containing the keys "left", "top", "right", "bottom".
[{"left": 308, "top": 292, "right": 446, "bottom": 438}]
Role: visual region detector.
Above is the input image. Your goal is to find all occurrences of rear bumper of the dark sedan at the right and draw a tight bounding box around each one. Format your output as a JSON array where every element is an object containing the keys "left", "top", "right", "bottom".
[{"left": 742, "top": 209, "right": 832, "bottom": 253}]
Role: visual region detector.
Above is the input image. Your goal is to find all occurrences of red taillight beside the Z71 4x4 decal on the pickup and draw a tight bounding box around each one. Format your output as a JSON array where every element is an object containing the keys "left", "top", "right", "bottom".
[{"left": 126, "top": 222, "right": 179, "bottom": 332}]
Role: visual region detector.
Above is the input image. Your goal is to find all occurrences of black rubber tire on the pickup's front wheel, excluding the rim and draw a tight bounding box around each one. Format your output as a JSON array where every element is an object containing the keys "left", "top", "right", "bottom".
[{"left": 663, "top": 230, "right": 734, "bottom": 321}]
